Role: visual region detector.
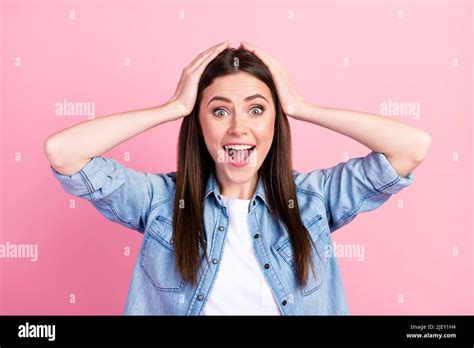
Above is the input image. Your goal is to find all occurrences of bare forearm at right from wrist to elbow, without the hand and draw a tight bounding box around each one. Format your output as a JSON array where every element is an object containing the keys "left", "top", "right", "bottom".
[{"left": 297, "top": 103, "right": 431, "bottom": 177}]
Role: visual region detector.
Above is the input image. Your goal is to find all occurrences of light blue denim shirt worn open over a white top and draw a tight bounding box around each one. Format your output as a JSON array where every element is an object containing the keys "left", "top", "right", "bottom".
[{"left": 51, "top": 151, "right": 414, "bottom": 315}]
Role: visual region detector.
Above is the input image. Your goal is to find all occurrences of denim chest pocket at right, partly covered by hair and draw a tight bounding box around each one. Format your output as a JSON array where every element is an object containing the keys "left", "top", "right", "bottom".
[{"left": 274, "top": 214, "right": 331, "bottom": 296}]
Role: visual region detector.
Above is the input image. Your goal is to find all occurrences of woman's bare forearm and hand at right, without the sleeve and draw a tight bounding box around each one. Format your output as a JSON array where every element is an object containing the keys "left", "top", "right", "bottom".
[{"left": 241, "top": 42, "right": 431, "bottom": 177}]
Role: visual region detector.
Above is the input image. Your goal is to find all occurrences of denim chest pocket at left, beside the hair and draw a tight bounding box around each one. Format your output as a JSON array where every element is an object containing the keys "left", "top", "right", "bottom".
[{"left": 140, "top": 216, "right": 184, "bottom": 292}]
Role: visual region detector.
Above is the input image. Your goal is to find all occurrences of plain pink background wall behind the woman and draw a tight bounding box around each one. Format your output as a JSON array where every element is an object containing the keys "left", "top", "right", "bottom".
[{"left": 0, "top": 1, "right": 474, "bottom": 314}]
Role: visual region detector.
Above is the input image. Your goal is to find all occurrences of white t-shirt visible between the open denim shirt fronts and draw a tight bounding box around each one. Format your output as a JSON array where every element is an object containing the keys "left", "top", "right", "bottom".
[{"left": 204, "top": 196, "right": 281, "bottom": 315}]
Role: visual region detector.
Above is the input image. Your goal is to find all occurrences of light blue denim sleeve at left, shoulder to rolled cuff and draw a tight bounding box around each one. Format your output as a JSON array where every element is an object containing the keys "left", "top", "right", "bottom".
[{"left": 50, "top": 157, "right": 176, "bottom": 233}]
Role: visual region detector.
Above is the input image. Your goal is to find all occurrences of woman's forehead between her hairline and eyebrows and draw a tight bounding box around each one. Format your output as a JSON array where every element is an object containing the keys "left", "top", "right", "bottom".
[{"left": 202, "top": 72, "right": 271, "bottom": 101}]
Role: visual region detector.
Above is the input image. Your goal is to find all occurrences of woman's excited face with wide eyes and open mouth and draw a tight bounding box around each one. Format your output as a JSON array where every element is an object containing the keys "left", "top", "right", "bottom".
[{"left": 199, "top": 72, "right": 275, "bottom": 190}]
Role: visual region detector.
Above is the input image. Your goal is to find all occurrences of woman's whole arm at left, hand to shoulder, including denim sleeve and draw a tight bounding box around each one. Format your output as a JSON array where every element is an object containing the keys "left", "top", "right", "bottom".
[{"left": 44, "top": 42, "right": 228, "bottom": 232}]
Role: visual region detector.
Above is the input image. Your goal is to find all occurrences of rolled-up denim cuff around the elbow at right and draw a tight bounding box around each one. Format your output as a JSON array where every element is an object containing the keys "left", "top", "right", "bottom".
[{"left": 362, "top": 151, "right": 415, "bottom": 194}]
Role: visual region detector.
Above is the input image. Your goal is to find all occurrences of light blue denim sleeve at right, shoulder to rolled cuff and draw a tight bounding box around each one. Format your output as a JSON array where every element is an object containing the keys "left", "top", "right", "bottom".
[{"left": 294, "top": 151, "right": 415, "bottom": 233}]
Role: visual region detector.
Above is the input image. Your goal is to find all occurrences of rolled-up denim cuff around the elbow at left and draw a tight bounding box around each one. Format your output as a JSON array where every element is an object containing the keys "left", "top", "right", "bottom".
[{"left": 50, "top": 157, "right": 108, "bottom": 196}]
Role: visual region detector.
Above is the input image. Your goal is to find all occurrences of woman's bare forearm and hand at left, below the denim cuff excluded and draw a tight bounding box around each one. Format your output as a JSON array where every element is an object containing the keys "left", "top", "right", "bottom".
[{"left": 44, "top": 41, "right": 230, "bottom": 175}]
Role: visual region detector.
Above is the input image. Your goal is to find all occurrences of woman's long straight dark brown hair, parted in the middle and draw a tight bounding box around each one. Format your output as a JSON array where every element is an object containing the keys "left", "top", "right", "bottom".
[{"left": 173, "top": 48, "right": 314, "bottom": 286}]
